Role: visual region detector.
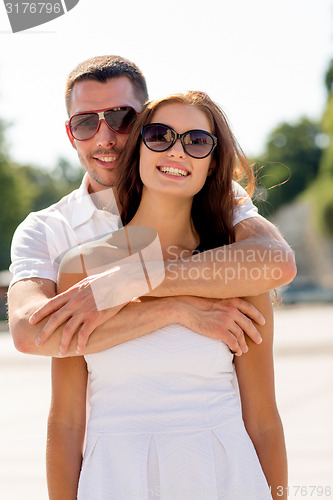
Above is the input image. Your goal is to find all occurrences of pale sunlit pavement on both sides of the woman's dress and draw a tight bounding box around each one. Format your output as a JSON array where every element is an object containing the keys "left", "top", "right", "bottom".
[{"left": 0, "top": 306, "right": 333, "bottom": 500}]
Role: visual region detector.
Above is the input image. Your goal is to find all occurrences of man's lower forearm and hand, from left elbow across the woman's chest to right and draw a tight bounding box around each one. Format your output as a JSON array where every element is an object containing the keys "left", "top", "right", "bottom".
[{"left": 8, "top": 278, "right": 264, "bottom": 357}]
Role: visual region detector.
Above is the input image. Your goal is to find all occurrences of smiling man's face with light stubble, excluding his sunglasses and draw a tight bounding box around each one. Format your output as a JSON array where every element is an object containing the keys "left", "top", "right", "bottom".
[{"left": 67, "top": 76, "right": 142, "bottom": 192}]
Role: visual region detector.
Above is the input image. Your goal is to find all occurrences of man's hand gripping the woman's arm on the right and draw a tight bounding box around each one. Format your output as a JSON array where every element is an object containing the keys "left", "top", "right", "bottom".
[{"left": 175, "top": 296, "right": 265, "bottom": 356}]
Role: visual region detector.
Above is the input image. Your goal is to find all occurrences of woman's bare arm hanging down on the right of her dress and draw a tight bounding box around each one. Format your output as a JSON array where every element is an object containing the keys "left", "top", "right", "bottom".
[{"left": 235, "top": 293, "right": 288, "bottom": 500}]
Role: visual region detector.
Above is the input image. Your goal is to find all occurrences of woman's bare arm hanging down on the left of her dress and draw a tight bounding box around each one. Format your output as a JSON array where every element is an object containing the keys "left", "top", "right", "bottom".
[{"left": 46, "top": 264, "right": 88, "bottom": 500}]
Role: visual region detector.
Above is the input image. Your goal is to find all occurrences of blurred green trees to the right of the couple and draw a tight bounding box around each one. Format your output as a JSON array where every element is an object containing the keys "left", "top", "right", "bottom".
[{"left": 249, "top": 59, "right": 333, "bottom": 237}]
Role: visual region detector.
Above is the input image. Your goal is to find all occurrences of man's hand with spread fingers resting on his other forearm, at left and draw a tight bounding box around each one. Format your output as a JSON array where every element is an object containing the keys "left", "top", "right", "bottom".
[{"left": 29, "top": 278, "right": 125, "bottom": 356}]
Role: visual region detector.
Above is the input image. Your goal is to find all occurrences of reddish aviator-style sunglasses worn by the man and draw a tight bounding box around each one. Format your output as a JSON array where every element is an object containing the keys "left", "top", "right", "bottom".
[{"left": 67, "top": 106, "right": 138, "bottom": 141}]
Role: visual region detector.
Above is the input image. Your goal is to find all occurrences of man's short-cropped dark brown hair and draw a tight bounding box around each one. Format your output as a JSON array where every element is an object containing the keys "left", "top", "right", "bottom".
[{"left": 65, "top": 56, "right": 148, "bottom": 115}]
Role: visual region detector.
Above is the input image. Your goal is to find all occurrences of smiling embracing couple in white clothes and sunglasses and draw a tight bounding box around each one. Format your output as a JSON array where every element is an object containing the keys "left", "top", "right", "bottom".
[{"left": 9, "top": 56, "right": 295, "bottom": 500}]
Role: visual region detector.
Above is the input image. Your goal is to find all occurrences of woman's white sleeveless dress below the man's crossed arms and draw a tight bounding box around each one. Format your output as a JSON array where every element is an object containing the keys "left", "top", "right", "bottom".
[{"left": 78, "top": 325, "right": 274, "bottom": 500}]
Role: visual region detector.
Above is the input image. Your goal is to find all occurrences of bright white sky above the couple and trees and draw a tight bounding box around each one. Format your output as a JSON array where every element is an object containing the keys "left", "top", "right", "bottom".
[{"left": 0, "top": 0, "right": 333, "bottom": 168}]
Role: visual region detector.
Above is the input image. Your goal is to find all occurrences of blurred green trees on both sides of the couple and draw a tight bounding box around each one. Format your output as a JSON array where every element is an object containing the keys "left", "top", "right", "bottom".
[{"left": 0, "top": 59, "right": 333, "bottom": 270}]
